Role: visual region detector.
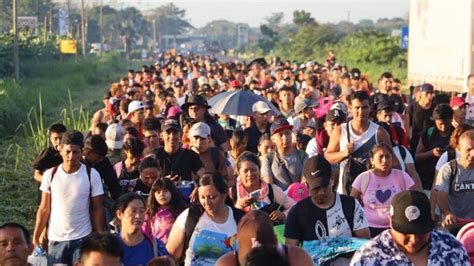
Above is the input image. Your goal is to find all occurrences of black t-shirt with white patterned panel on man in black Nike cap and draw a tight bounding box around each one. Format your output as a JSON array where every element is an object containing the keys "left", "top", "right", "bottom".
[{"left": 285, "top": 193, "right": 368, "bottom": 243}]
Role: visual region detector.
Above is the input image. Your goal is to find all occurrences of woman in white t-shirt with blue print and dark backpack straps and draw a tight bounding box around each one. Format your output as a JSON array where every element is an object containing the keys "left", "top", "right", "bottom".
[{"left": 166, "top": 173, "right": 244, "bottom": 266}]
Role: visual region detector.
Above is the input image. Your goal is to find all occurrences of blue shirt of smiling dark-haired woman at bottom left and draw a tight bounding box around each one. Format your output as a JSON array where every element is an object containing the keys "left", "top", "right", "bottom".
[{"left": 117, "top": 236, "right": 169, "bottom": 266}]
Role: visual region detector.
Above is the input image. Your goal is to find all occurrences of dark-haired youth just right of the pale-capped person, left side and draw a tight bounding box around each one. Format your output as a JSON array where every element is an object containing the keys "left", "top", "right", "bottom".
[{"left": 114, "top": 138, "right": 145, "bottom": 180}]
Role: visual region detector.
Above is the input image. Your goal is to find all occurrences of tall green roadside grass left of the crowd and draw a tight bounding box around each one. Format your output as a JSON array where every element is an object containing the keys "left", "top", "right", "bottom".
[{"left": 0, "top": 55, "right": 148, "bottom": 230}]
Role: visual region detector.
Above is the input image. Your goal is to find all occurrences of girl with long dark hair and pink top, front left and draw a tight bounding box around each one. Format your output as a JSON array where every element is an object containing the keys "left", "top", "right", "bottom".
[{"left": 142, "top": 178, "right": 187, "bottom": 244}]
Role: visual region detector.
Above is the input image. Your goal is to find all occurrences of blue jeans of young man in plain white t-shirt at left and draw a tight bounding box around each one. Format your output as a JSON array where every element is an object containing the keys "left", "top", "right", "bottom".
[{"left": 48, "top": 238, "right": 84, "bottom": 265}]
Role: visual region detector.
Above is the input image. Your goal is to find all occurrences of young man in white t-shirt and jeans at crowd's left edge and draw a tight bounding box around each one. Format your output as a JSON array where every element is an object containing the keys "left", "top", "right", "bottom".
[{"left": 33, "top": 130, "right": 105, "bottom": 265}]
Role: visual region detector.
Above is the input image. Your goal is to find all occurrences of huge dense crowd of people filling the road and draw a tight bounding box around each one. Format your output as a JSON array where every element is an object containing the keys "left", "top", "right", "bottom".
[{"left": 4, "top": 52, "right": 474, "bottom": 266}]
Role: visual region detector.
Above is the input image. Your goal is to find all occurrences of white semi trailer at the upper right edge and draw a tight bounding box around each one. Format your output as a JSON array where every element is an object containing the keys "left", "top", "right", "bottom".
[{"left": 408, "top": 0, "right": 474, "bottom": 92}]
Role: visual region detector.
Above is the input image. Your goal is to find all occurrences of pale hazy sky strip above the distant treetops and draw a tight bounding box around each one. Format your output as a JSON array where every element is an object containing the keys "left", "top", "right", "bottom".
[{"left": 99, "top": 0, "right": 410, "bottom": 27}]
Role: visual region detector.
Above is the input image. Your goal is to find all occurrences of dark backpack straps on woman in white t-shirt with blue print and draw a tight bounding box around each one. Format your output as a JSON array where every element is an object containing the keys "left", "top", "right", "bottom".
[{"left": 181, "top": 204, "right": 245, "bottom": 262}]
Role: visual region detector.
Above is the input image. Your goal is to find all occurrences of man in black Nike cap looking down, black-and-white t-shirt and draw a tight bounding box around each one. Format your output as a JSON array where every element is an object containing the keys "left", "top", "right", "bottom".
[{"left": 284, "top": 155, "right": 370, "bottom": 265}]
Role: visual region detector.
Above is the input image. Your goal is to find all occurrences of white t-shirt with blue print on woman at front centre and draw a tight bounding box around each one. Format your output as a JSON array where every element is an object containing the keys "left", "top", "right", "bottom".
[{"left": 175, "top": 206, "right": 237, "bottom": 265}]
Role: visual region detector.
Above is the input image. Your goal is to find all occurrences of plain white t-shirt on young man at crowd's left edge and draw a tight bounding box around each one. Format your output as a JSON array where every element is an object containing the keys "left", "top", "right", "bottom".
[{"left": 40, "top": 164, "right": 104, "bottom": 241}]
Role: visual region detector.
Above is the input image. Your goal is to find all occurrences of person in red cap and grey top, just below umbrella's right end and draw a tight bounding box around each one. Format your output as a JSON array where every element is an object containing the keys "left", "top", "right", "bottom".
[{"left": 261, "top": 120, "right": 308, "bottom": 190}]
